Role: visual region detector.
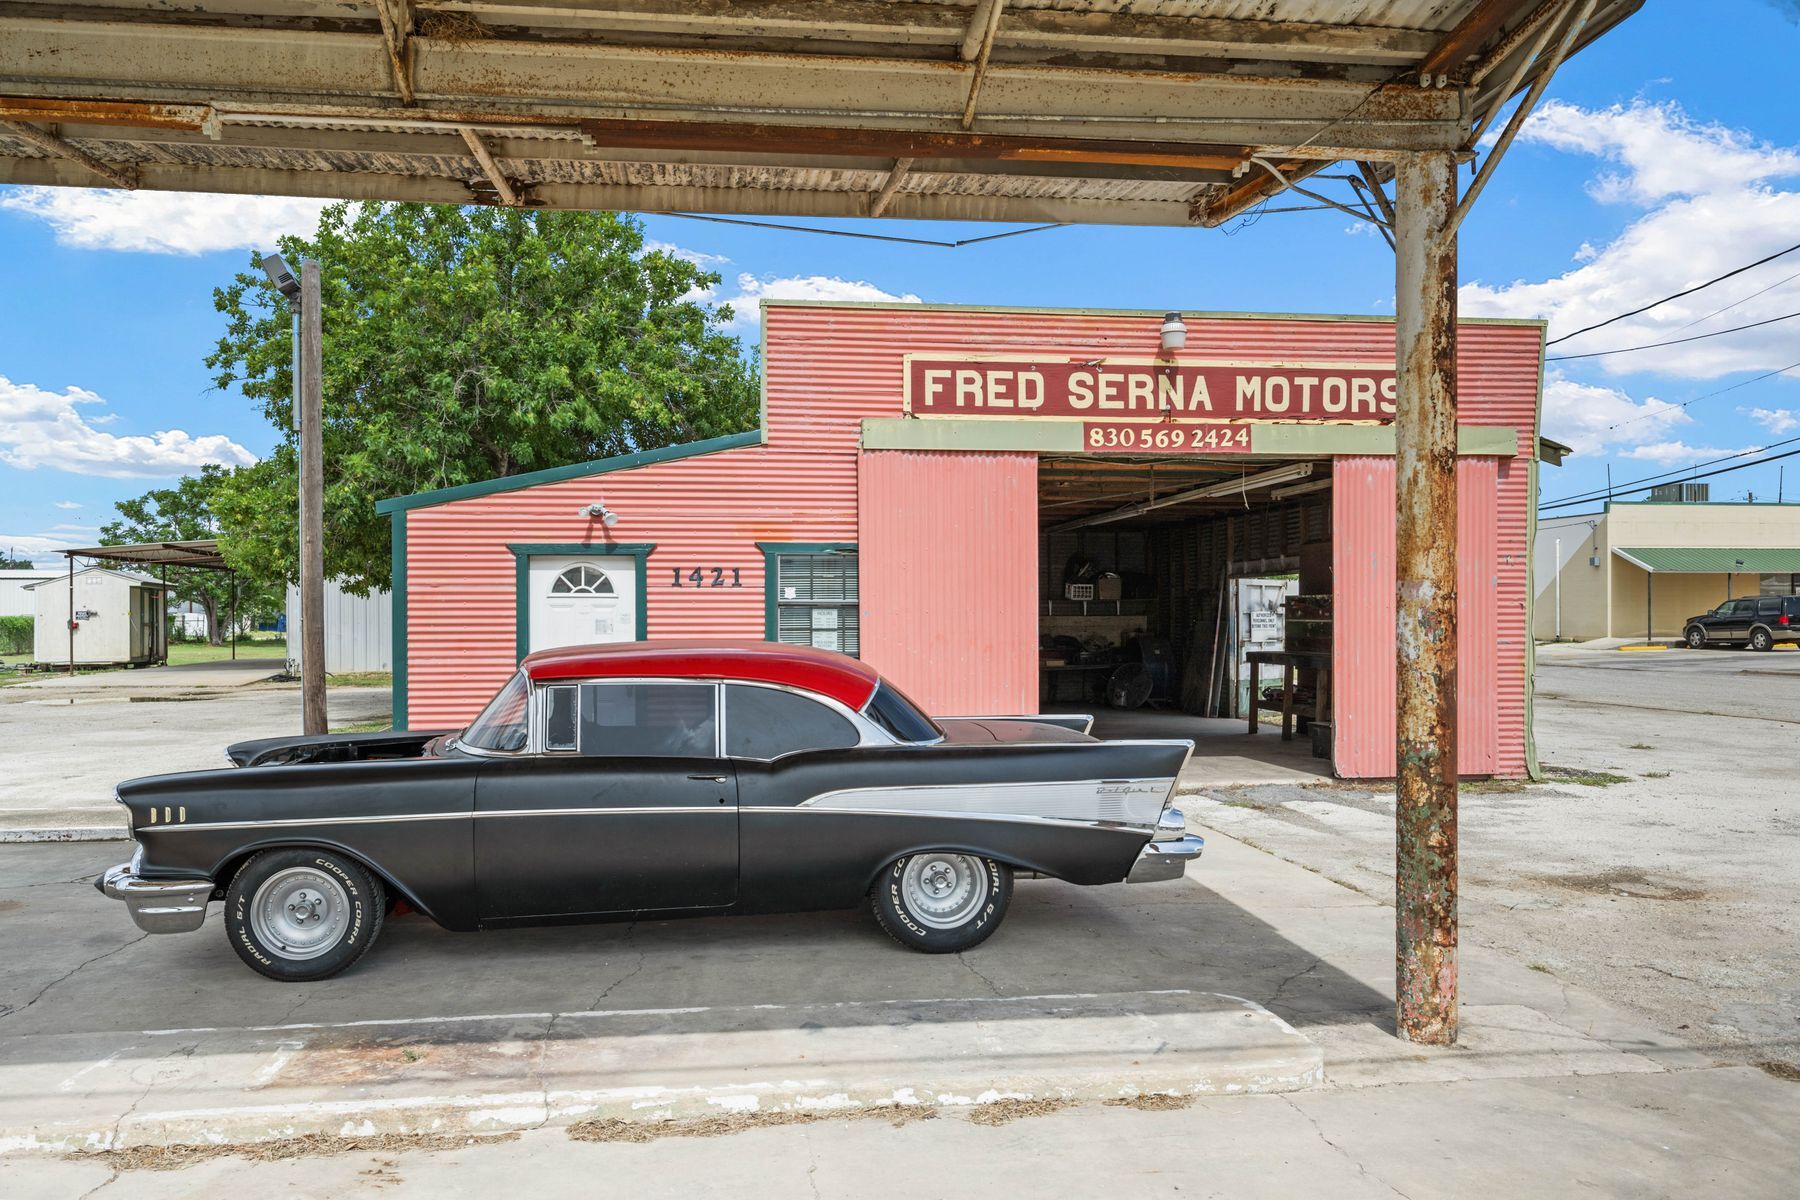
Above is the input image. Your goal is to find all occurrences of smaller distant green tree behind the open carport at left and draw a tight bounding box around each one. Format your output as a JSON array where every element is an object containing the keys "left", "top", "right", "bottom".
[{"left": 101, "top": 464, "right": 284, "bottom": 646}]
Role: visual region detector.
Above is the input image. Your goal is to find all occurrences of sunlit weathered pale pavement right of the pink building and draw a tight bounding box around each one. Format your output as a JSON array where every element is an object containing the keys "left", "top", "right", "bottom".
[{"left": 1183, "top": 649, "right": 1800, "bottom": 1072}]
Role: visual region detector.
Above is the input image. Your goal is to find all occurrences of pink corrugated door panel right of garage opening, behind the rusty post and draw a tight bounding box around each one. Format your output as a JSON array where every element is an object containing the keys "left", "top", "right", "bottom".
[{"left": 1332, "top": 455, "right": 1525, "bottom": 779}]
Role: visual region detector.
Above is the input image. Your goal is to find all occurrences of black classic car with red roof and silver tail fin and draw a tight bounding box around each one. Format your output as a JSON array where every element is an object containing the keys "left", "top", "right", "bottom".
[{"left": 97, "top": 642, "right": 1202, "bottom": 982}]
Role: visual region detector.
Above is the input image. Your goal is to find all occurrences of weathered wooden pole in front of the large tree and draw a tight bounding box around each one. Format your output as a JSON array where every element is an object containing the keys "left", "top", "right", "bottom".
[{"left": 299, "top": 259, "right": 326, "bottom": 736}]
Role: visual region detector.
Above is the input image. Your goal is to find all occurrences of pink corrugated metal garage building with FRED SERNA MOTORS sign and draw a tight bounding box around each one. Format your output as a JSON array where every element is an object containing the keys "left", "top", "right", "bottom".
[{"left": 380, "top": 302, "right": 1543, "bottom": 777}]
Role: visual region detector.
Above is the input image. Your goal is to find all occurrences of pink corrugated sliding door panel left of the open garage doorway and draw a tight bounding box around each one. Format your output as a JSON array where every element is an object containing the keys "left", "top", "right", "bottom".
[{"left": 857, "top": 450, "right": 1037, "bottom": 714}]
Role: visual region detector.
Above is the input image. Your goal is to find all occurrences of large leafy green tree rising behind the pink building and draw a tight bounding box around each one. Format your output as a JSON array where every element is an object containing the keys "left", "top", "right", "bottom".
[{"left": 207, "top": 205, "right": 756, "bottom": 592}]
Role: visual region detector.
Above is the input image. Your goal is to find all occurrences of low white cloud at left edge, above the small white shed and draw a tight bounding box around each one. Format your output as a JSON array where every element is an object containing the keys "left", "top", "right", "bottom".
[{"left": 0, "top": 376, "right": 256, "bottom": 482}]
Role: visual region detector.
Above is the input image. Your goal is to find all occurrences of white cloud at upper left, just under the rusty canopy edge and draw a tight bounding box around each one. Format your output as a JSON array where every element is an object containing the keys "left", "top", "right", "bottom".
[{"left": 0, "top": 187, "right": 333, "bottom": 254}]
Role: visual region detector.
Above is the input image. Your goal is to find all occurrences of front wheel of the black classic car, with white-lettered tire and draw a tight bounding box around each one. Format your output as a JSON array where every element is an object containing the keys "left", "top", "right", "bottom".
[{"left": 225, "top": 849, "right": 387, "bottom": 984}]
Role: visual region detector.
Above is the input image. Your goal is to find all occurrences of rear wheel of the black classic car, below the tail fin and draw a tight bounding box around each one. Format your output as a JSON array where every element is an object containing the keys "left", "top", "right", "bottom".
[{"left": 869, "top": 851, "right": 1012, "bottom": 954}]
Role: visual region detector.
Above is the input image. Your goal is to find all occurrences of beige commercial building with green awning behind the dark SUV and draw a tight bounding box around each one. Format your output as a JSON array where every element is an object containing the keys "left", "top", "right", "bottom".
[{"left": 1532, "top": 500, "right": 1800, "bottom": 640}]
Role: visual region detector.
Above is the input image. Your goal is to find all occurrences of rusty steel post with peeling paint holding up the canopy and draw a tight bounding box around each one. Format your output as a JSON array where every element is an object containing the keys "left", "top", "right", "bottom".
[{"left": 1395, "top": 151, "right": 1456, "bottom": 1045}]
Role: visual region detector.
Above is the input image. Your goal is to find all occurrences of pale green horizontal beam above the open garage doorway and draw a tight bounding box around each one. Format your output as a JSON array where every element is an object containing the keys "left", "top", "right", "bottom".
[{"left": 862, "top": 417, "right": 1519, "bottom": 459}]
